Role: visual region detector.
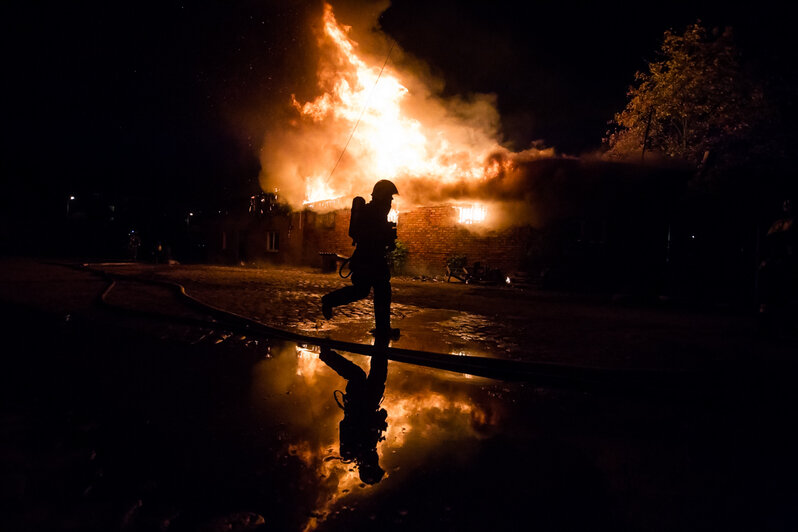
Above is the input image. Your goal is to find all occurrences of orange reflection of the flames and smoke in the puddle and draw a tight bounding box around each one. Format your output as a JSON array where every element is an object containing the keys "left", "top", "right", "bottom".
[{"left": 252, "top": 344, "right": 502, "bottom": 530}]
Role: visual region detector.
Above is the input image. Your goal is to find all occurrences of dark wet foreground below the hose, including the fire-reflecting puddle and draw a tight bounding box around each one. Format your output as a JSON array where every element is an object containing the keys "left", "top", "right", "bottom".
[{"left": 0, "top": 260, "right": 798, "bottom": 531}]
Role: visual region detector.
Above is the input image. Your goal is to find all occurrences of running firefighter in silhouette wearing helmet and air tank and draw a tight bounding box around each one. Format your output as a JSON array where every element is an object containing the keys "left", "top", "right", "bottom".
[{"left": 321, "top": 179, "right": 399, "bottom": 335}]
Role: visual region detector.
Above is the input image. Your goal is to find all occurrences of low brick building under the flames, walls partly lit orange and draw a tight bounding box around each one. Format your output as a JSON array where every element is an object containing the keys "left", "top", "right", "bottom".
[{"left": 214, "top": 157, "right": 687, "bottom": 298}]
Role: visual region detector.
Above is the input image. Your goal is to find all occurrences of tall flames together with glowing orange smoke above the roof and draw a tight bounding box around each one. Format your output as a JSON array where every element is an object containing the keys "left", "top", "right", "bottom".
[{"left": 262, "top": 4, "right": 540, "bottom": 210}]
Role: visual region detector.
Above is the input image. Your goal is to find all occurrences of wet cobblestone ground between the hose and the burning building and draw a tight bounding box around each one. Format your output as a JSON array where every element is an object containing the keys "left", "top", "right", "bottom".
[{"left": 92, "top": 264, "right": 794, "bottom": 369}]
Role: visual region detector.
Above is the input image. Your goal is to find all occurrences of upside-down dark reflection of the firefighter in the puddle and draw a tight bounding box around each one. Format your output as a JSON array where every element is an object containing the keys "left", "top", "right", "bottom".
[{"left": 319, "top": 340, "right": 388, "bottom": 484}]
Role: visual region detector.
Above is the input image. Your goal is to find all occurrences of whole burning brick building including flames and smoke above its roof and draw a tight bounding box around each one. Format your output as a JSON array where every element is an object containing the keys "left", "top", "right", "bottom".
[{"left": 209, "top": 4, "right": 683, "bottom": 290}]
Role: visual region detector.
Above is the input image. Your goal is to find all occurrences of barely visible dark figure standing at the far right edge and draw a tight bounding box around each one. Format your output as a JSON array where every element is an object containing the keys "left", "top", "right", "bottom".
[{"left": 759, "top": 200, "right": 798, "bottom": 332}]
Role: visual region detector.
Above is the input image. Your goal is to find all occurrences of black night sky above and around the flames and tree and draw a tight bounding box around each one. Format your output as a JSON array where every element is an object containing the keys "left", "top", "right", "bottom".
[{"left": 2, "top": 0, "right": 794, "bottom": 212}]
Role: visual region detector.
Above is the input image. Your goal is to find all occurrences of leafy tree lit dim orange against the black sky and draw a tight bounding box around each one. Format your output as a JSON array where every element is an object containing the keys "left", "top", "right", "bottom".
[{"left": 605, "top": 22, "right": 776, "bottom": 182}]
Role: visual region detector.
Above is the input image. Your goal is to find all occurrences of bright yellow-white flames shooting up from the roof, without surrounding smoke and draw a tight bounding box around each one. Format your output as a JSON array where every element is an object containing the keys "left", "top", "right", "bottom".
[{"left": 285, "top": 4, "right": 502, "bottom": 203}]
